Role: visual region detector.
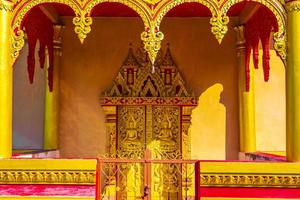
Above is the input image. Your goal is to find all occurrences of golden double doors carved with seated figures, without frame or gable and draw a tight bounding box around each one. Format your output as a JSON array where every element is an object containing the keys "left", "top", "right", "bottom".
[{"left": 117, "top": 105, "right": 181, "bottom": 200}]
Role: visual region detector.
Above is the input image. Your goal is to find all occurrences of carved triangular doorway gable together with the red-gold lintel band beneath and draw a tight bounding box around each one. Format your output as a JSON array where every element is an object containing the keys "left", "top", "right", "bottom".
[{"left": 103, "top": 47, "right": 196, "bottom": 99}]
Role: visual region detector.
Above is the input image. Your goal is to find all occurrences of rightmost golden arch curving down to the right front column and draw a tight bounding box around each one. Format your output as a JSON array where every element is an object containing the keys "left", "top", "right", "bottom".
[{"left": 221, "top": 0, "right": 287, "bottom": 64}]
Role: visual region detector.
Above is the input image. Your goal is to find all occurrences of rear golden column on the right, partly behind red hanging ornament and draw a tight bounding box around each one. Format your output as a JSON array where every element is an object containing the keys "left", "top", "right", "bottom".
[{"left": 235, "top": 26, "right": 256, "bottom": 152}]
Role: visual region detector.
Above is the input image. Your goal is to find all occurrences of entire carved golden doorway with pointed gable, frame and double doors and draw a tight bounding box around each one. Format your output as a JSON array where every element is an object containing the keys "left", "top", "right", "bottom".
[{"left": 101, "top": 44, "right": 196, "bottom": 200}]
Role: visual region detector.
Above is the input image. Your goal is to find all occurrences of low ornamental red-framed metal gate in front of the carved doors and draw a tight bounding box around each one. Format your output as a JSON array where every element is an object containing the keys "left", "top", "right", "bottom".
[{"left": 96, "top": 149, "right": 200, "bottom": 200}]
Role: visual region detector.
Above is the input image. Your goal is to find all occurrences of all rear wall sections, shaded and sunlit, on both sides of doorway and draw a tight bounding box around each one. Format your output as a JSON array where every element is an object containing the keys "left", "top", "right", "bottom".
[{"left": 13, "top": 17, "right": 285, "bottom": 159}]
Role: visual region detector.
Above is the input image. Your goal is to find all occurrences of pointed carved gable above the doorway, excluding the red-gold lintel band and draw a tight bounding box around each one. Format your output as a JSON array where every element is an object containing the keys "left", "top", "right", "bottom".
[{"left": 104, "top": 45, "right": 194, "bottom": 97}]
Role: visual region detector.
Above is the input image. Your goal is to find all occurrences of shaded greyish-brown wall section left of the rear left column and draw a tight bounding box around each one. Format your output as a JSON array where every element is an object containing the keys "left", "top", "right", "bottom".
[{"left": 13, "top": 41, "right": 45, "bottom": 149}]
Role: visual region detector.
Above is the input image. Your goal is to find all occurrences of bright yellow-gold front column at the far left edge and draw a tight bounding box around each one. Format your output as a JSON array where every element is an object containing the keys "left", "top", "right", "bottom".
[{"left": 0, "top": 0, "right": 13, "bottom": 158}]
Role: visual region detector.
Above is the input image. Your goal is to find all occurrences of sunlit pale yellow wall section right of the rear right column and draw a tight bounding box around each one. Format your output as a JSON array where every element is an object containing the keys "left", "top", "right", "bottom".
[{"left": 254, "top": 50, "right": 286, "bottom": 151}]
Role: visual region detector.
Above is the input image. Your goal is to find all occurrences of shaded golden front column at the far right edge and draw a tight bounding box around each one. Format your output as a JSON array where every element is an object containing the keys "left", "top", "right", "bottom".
[{"left": 286, "top": 0, "right": 300, "bottom": 162}]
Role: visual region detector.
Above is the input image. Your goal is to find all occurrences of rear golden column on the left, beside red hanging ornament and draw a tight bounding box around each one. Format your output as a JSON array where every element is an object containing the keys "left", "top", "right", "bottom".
[{"left": 44, "top": 25, "right": 63, "bottom": 150}]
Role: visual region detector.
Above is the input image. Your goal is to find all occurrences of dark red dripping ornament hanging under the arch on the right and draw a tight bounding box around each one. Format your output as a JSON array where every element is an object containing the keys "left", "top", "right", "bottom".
[{"left": 245, "top": 6, "right": 278, "bottom": 91}]
